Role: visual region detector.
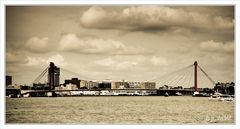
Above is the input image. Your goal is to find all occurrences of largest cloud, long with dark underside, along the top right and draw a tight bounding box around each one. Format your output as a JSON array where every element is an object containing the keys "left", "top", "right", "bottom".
[{"left": 80, "top": 6, "right": 234, "bottom": 30}]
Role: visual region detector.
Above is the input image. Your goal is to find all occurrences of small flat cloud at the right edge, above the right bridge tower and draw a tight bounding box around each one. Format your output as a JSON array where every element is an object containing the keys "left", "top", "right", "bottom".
[{"left": 200, "top": 40, "right": 234, "bottom": 52}]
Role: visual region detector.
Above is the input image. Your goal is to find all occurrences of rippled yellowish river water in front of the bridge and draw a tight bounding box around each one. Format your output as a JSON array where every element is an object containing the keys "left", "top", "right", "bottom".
[{"left": 6, "top": 96, "right": 235, "bottom": 124}]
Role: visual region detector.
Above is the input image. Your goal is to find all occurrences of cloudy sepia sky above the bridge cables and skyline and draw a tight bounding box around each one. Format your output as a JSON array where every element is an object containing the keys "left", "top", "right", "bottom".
[{"left": 6, "top": 5, "right": 235, "bottom": 87}]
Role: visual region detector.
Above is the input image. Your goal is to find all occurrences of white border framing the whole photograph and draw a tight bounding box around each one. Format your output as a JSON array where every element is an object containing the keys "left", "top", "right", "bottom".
[{"left": 0, "top": 0, "right": 240, "bottom": 129}]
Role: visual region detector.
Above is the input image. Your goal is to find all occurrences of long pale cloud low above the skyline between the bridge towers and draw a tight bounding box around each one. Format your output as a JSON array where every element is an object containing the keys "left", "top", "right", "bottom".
[{"left": 93, "top": 55, "right": 168, "bottom": 70}]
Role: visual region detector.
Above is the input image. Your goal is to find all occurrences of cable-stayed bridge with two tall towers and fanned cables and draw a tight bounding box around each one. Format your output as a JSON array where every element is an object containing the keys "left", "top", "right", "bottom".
[{"left": 24, "top": 61, "right": 215, "bottom": 94}]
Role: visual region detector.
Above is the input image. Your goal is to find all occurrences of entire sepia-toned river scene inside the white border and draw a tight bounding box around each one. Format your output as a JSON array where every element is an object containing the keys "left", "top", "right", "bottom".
[{"left": 5, "top": 5, "right": 236, "bottom": 125}]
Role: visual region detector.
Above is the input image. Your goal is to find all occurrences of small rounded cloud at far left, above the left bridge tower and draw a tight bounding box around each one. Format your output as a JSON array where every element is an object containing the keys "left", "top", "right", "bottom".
[{"left": 25, "top": 37, "right": 49, "bottom": 53}]
